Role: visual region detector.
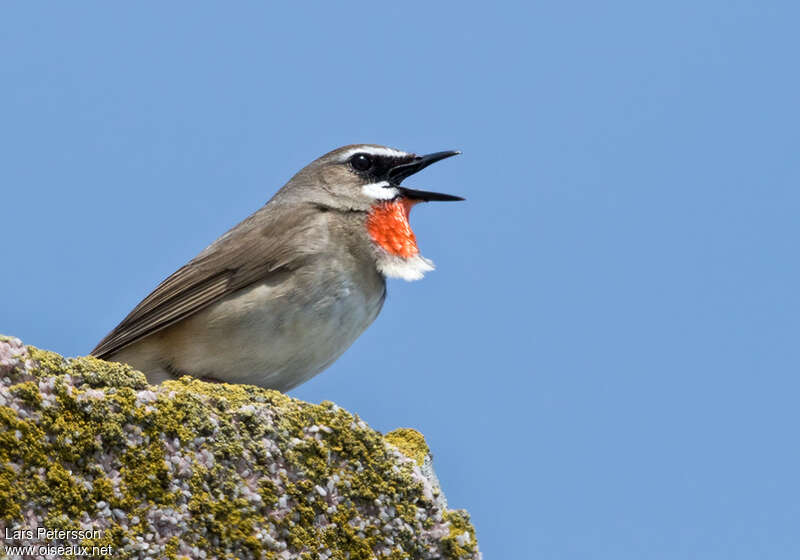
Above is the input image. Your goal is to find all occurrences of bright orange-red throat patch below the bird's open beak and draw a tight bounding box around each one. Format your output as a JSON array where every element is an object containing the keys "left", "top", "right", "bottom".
[{"left": 367, "top": 198, "right": 419, "bottom": 258}]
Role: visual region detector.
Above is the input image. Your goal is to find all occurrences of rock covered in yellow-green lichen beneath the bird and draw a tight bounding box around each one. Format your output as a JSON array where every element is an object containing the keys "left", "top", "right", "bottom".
[{"left": 0, "top": 337, "right": 480, "bottom": 560}]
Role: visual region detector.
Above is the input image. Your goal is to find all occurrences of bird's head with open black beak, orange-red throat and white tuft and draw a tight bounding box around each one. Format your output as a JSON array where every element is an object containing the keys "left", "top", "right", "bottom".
[{"left": 293, "top": 144, "right": 464, "bottom": 280}]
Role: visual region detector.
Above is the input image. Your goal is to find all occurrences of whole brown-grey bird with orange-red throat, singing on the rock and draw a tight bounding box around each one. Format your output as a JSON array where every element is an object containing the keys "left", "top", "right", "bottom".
[{"left": 91, "top": 144, "right": 464, "bottom": 392}]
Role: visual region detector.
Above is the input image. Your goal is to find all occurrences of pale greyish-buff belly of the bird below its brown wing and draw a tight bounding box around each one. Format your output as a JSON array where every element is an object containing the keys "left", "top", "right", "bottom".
[{"left": 159, "top": 267, "right": 385, "bottom": 391}]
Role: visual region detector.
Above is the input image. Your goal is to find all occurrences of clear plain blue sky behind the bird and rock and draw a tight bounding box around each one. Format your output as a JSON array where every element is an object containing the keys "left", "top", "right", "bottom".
[{"left": 0, "top": 1, "right": 800, "bottom": 560}]
